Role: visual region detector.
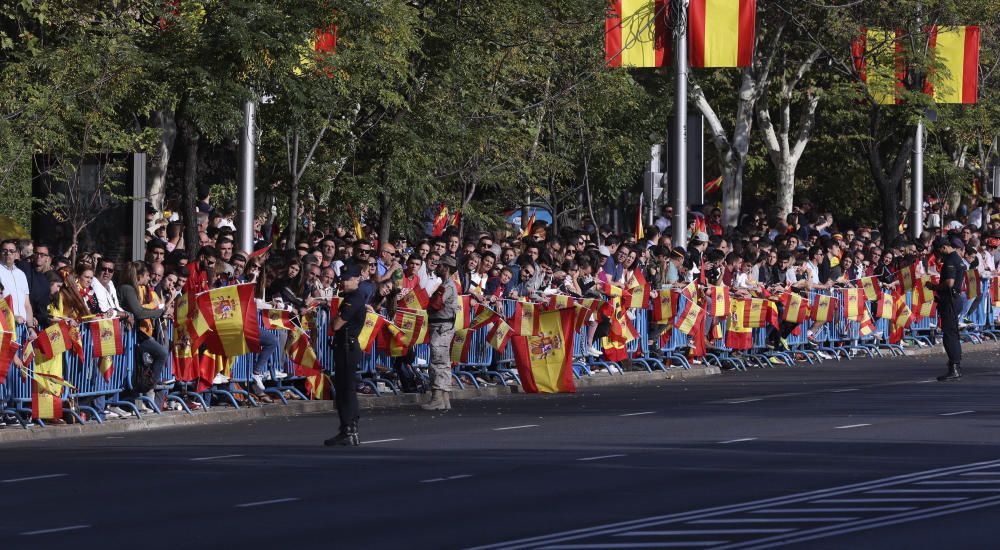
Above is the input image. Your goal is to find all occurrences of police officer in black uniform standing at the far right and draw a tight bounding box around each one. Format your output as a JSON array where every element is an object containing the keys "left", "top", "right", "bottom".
[{"left": 929, "top": 237, "right": 965, "bottom": 382}]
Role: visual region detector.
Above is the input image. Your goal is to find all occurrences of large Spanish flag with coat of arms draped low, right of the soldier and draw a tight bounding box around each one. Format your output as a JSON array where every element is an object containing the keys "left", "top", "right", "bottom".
[{"left": 511, "top": 309, "right": 576, "bottom": 393}]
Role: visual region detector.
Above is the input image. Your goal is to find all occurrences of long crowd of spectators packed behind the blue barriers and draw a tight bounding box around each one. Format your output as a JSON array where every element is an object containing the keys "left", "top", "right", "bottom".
[{"left": 0, "top": 194, "right": 1000, "bottom": 430}]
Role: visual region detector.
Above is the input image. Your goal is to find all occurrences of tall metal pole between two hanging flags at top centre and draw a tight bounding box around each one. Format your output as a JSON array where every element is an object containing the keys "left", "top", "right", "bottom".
[{"left": 670, "top": 0, "right": 688, "bottom": 246}]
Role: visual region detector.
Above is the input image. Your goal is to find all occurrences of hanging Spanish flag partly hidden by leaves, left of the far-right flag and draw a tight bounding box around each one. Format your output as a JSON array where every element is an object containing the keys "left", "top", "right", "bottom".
[{"left": 851, "top": 27, "right": 906, "bottom": 105}]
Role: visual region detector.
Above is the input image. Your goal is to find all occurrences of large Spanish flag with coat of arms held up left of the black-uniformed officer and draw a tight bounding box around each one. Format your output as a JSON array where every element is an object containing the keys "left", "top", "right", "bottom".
[{"left": 197, "top": 284, "right": 260, "bottom": 357}]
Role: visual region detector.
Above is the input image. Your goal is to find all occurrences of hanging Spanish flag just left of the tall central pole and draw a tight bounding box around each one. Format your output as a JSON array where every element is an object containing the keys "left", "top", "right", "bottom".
[{"left": 604, "top": 0, "right": 671, "bottom": 67}]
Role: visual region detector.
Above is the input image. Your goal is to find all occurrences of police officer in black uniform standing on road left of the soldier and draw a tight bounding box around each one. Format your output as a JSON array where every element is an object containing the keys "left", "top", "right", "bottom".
[{"left": 323, "top": 264, "right": 368, "bottom": 447}]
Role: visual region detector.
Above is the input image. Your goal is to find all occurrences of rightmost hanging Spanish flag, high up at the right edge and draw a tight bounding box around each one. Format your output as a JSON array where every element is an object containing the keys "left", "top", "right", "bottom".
[{"left": 924, "top": 26, "right": 980, "bottom": 105}]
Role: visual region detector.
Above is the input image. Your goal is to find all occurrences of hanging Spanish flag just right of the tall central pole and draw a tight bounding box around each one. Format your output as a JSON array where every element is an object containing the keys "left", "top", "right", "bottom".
[{"left": 688, "top": 0, "right": 757, "bottom": 67}]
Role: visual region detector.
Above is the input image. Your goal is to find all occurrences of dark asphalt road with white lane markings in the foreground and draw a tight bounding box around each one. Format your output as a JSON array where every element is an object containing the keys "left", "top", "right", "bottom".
[{"left": 0, "top": 349, "right": 1000, "bottom": 550}]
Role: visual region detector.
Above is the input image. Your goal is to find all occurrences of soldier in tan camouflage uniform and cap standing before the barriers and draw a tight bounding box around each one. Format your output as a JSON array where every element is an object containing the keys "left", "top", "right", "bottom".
[{"left": 422, "top": 256, "right": 459, "bottom": 411}]
